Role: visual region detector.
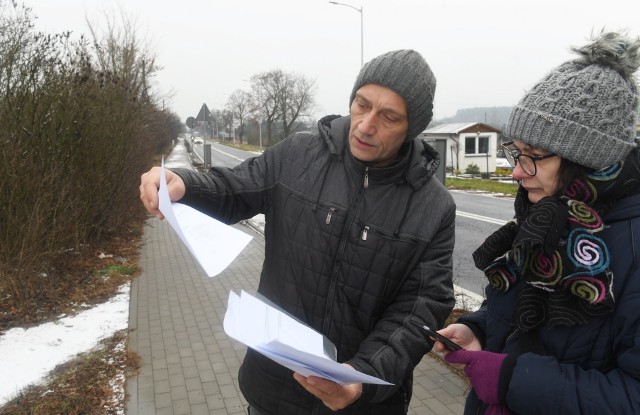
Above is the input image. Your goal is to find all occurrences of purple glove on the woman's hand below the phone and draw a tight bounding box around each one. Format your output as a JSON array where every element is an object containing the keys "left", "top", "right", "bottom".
[{"left": 444, "top": 350, "right": 516, "bottom": 406}]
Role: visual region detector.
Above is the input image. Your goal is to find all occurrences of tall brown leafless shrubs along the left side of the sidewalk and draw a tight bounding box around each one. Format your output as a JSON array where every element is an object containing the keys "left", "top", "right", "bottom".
[{"left": 0, "top": 0, "right": 177, "bottom": 308}]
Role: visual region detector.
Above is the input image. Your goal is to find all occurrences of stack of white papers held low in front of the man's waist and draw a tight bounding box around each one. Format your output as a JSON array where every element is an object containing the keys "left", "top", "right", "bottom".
[{"left": 224, "top": 291, "right": 391, "bottom": 385}]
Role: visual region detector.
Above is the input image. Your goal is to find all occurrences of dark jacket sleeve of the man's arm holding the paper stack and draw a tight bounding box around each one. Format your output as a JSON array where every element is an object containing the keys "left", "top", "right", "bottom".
[{"left": 346, "top": 206, "right": 455, "bottom": 402}]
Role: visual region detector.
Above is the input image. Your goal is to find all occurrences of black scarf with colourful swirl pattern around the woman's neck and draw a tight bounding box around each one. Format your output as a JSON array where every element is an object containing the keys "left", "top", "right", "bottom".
[{"left": 473, "top": 147, "right": 640, "bottom": 332}]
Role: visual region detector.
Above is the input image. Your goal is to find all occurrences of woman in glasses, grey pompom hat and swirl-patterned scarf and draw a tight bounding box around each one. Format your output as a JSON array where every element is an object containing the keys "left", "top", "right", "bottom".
[{"left": 435, "top": 33, "right": 640, "bottom": 415}]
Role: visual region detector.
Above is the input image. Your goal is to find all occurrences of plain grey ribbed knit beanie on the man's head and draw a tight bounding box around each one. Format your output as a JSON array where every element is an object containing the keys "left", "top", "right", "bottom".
[{"left": 349, "top": 49, "right": 436, "bottom": 140}]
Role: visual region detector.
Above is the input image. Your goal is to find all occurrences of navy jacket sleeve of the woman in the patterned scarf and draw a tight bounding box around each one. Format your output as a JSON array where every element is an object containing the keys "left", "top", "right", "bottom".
[{"left": 507, "top": 270, "right": 640, "bottom": 415}]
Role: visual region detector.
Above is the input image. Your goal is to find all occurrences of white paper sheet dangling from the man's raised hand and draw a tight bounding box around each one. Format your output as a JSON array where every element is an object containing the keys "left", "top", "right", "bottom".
[{"left": 158, "top": 159, "right": 251, "bottom": 277}]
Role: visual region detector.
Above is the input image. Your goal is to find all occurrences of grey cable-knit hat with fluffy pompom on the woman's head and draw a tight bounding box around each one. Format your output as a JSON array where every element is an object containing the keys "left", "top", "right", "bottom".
[{"left": 504, "top": 32, "right": 640, "bottom": 170}]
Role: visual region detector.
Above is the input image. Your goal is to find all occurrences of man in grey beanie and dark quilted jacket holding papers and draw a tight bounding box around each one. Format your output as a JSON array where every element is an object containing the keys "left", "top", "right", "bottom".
[{"left": 140, "top": 50, "right": 455, "bottom": 415}]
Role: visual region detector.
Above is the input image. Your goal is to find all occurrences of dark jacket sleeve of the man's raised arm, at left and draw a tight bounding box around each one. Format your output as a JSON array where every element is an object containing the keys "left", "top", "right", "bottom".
[{"left": 172, "top": 140, "right": 288, "bottom": 224}]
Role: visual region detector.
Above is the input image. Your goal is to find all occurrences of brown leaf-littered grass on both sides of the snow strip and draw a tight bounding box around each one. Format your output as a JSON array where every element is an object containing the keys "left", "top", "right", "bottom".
[{"left": 0, "top": 218, "right": 144, "bottom": 415}]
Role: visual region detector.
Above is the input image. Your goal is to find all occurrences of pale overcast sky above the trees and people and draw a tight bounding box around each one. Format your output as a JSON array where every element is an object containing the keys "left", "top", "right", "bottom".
[{"left": 24, "top": 0, "right": 640, "bottom": 121}]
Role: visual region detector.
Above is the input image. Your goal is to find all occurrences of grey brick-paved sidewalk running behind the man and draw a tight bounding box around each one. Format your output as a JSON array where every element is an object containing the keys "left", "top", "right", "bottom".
[{"left": 127, "top": 141, "right": 467, "bottom": 415}]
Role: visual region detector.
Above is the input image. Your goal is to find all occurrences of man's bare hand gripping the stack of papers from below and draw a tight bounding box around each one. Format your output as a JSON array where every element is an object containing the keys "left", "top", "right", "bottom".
[{"left": 293, "top": 364, "right": 362, "bottom": 411}]
